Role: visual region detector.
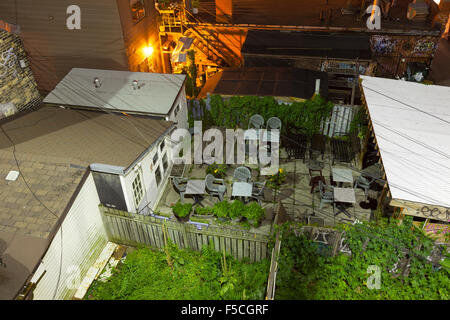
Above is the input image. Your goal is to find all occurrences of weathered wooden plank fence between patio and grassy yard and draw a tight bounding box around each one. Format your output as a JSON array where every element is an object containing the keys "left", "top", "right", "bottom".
[{"left": 100, "top": 205, "right": 270, "bottom": 262}]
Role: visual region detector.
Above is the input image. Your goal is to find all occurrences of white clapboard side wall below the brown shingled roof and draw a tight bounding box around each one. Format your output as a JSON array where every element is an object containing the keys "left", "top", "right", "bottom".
[{"left": 32, "top": 174, "right": 107, "bottom": 300}]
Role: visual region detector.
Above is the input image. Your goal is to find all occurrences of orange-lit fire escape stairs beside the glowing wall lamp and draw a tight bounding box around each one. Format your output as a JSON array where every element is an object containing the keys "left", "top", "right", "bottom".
[{"left": 159, "top": 5, "right": 242, "bottom": 73}]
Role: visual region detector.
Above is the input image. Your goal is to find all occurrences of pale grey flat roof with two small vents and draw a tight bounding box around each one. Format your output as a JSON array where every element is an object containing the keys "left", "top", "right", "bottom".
[{"left": 44, "top": 68, "right": 186, "bottom": 115}]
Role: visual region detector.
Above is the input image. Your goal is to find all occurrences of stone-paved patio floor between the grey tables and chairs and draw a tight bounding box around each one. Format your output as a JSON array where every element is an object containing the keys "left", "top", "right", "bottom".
[{"left": 156, "top": 141, "right": 378, "bottom": 229}]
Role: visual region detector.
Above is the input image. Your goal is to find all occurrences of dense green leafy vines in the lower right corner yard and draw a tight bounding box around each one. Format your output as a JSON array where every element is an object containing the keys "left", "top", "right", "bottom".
[{"left": 275, "top": 217, "right": 450, "bottom": 300}]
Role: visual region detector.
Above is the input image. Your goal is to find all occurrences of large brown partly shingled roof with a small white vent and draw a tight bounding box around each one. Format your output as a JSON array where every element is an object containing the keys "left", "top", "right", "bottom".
[{"left": 0, "top": 107, "right": 173, "bottom": 299}]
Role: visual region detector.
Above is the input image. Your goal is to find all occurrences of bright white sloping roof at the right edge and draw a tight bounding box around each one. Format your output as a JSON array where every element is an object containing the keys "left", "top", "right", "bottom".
[{"left": 361, "top": 76, "right": 450, "bottom": 207}]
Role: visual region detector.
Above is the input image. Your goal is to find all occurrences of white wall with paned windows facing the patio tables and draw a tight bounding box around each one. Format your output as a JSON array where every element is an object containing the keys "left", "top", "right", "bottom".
[{"left": 121, "top": 136, "right": 172, "bottom": 212}]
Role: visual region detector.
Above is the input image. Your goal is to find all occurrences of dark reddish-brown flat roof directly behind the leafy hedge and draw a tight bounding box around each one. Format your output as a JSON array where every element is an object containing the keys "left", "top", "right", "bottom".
[{"left": 202, "top": 67, "right": 328, "bottom": 99}]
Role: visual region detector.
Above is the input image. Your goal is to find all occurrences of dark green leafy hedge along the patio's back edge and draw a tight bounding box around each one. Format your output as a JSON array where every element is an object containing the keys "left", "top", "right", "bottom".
[{"left": 207, "top": 95, "right": 333, "bottom": 134}]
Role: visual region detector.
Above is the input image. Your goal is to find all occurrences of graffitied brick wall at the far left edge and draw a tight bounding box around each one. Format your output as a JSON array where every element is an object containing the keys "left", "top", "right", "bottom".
[{"left": 0, "top": 28, "right": 41, "bottom": 119}]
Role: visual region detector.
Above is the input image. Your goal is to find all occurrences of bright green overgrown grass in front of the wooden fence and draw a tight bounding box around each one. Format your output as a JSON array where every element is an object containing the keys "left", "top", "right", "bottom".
[{"left": 87, "top": 240, "right": 270, "bottom": 300}]
